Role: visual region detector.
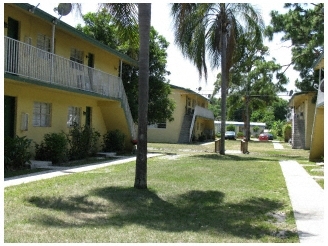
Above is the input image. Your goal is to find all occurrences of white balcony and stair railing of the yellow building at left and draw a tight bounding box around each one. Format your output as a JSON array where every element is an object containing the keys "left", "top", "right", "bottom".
[{"left": 4, "top": 37, "right": 136, "bottom": 138}]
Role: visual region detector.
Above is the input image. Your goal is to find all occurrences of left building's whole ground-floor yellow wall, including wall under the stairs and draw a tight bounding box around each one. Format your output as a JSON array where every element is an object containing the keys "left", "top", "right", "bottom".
[{"left": 4, "top": 79, "right": 131, "bottom": 152}]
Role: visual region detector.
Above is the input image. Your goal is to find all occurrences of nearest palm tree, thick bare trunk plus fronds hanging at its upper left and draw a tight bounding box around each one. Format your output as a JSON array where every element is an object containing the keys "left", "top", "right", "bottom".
[{"left": 101, "top": 3, "right": 151, "bottom": 189}]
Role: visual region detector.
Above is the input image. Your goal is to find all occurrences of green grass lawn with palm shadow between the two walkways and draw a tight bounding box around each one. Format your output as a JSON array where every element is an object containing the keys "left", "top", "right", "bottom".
[{"left": 4, "top": 141, "right": 314, "bottom": 243}]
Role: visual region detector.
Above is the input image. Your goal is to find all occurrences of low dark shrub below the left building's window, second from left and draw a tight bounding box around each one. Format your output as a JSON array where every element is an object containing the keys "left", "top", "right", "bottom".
[{"left": 35, "top": 133, "right": 68, "bottom": 164}]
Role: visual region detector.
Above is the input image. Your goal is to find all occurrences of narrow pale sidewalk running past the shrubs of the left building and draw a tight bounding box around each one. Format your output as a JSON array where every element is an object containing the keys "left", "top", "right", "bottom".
[{"left": 4, "top": 154, "right": 161, "bottom": 187}]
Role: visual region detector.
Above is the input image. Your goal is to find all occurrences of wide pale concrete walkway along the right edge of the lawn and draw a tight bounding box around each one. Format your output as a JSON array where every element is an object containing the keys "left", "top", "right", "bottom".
[{"left": 280, "top": 161, "right": 325, "bottom": 245}]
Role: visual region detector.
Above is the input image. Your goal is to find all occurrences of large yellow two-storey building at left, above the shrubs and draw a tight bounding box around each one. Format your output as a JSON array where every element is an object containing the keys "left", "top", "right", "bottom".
[{"left": 4, "top": 3, "right": 138, "bottom": 154}]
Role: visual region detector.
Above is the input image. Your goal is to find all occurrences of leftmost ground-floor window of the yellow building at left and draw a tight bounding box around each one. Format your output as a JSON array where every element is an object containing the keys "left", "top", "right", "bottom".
[{"left": 33, "top": 102, "right": 51, "bottom": 127}]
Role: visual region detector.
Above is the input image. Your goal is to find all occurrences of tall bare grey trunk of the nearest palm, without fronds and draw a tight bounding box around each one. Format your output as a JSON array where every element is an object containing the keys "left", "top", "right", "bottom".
[{"left": 134, "top": 3, "right": 151, "bottom": 189}]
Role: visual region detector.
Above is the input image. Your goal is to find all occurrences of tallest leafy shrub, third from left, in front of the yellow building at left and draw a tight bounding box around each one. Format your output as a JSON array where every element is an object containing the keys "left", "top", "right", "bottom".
[{"left": 66, "top": 123, "right": 100, "bottom": 160}]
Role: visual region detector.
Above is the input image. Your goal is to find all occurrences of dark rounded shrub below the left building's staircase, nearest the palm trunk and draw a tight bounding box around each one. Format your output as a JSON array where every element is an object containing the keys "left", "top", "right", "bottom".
[{"left": 103, "top": 129, "right": 125, "bottom": 152}]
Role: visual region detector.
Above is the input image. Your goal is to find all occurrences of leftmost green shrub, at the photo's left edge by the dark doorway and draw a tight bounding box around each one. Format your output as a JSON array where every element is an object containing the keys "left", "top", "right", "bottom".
[{"left": 4, "top": 136, "right": 32, "bottom": 170}]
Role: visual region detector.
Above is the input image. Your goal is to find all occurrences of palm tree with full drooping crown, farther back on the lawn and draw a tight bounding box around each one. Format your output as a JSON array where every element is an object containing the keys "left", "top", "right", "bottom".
[{"left": 171, "top": 3, "right": 264, "bottom": 155}]
